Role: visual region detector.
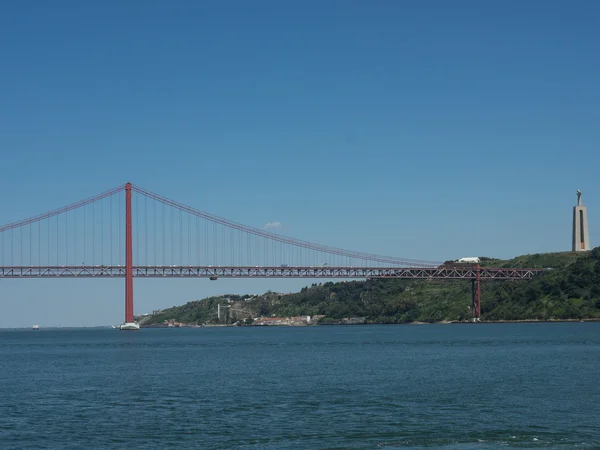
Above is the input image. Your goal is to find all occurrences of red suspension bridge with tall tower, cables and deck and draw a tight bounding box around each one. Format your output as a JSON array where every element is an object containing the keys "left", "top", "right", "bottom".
[{"left": 0, "top": 183, "right": 541, "bottom": 323}]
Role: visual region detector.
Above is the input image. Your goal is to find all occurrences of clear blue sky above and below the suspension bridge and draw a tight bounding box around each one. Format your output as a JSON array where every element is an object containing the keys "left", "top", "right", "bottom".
[{"left": 0, "top": 0, "right": 600, "bottom": 327}]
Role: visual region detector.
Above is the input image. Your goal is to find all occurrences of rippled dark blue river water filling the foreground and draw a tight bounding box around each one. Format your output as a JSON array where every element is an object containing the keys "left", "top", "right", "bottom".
[{"left": 0, "top": 323, "right": 600, "bottom": 449}]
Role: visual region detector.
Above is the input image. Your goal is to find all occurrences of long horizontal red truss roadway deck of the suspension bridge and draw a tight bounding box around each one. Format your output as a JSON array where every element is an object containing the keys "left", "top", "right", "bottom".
[{"left": 0, "top": 265, "right": 543, "bottom": 280}]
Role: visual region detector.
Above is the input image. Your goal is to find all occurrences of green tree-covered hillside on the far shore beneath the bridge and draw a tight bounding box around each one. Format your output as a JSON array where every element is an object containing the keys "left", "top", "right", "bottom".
[{"left": 138, "top": 247, "right": 600, "bottom": 324}]
